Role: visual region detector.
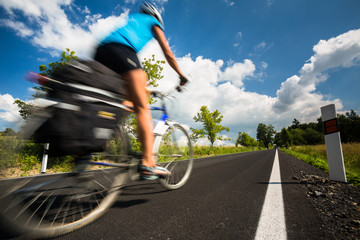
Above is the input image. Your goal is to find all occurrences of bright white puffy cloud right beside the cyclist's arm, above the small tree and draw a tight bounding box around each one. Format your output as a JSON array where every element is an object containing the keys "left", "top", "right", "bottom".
[{"left": 140, "top": 42, "right": 268, "bottom": 141}]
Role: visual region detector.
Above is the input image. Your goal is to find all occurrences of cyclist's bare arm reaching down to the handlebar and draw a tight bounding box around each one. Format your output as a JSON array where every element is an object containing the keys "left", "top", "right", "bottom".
[{"left": 153, "top": 26, "right": 186, "bottom": 79}]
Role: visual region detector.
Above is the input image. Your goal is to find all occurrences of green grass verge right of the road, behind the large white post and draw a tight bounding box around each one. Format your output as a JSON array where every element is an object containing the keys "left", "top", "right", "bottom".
[{"left": 281, "top": 143, "right": 360, "bottom": 186}]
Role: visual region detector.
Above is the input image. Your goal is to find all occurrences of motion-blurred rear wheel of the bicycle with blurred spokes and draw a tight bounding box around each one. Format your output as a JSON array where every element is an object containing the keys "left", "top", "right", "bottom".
[{"left": 0, "top": 125, "right": 128, "bottom": 238}]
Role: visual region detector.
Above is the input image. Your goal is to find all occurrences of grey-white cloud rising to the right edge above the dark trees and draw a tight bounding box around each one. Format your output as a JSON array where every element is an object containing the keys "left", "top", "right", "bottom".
[{"left": 274, "top": 29, "right": 360, "bottom": 113}]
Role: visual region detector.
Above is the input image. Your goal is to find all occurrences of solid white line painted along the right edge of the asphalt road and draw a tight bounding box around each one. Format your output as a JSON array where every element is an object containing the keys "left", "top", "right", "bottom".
[{"left": 255, "top": 150, "right": 287, "bottom": 240}]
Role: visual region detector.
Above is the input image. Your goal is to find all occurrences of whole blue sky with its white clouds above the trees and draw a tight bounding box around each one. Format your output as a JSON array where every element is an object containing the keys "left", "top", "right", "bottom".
[{"left": 0, "top": 0, "right": 360, "bottom": 145}]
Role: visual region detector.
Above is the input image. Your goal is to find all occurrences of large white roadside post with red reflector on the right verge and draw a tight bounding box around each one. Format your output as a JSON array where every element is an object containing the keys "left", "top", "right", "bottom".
[{"left": 321, "top": 104, "right": 346, "bottom": 182}]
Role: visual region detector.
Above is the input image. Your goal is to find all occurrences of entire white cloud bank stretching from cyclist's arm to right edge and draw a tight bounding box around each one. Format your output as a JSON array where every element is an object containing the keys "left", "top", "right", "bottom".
[{"left": 141, "top": 30, "right": 360, "bottom": 142}]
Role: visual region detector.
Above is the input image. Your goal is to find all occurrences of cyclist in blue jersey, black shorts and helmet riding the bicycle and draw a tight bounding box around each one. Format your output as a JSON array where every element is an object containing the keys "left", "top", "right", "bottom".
[{"left": 95, "top": 3, "right": 187, "bottom": 180}]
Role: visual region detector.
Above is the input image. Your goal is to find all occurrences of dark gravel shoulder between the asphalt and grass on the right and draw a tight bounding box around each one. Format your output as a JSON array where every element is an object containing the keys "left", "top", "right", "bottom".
[{"left": 281, "top": 152, "right": 360, "bottom": 240}]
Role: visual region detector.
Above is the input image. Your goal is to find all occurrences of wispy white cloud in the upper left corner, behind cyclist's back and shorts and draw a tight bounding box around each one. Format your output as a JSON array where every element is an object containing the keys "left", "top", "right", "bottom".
[{"left": 0, "top": 0, "right": 128, "bottom": 58}]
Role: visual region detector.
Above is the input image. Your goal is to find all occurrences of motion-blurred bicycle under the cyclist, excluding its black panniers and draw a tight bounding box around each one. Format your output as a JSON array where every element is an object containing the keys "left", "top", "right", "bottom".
[{"left": 0, "top": 66, "right": 193, "bottom": 238}]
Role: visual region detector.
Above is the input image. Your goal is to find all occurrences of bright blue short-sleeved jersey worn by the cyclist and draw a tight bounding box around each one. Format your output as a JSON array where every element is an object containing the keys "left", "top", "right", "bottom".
[{"left": 101, "top": 13, "right": 163, "bottom": 52}]
